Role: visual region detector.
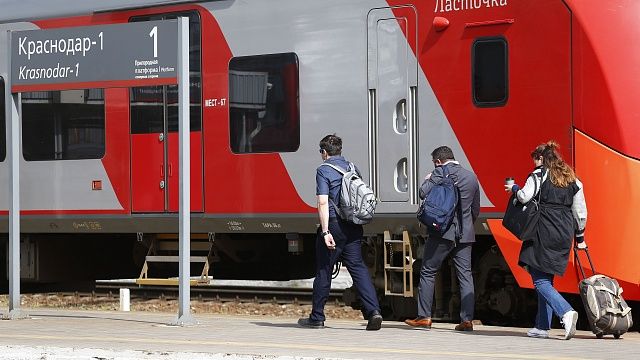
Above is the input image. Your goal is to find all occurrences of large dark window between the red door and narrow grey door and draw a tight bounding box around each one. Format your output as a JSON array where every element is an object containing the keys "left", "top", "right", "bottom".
[{"left": 229, "top": 53, "right": 300, "bottom": 154}]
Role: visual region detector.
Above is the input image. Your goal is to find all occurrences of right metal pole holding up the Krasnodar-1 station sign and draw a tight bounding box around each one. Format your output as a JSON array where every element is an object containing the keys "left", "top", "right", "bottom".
[{"left": 175, "top": 17, "right": 196, "bottom": 325}]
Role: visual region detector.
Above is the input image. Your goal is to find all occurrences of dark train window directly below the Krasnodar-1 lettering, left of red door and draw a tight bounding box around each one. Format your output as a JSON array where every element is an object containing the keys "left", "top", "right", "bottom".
[{"left": 22, "top": 89, "right": 105, "bottom": 161}]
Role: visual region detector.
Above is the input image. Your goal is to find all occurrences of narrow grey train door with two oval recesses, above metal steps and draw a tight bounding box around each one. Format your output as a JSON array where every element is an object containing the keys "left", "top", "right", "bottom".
[{"left": 367, "top": 6, "right": 417, "bottom": 211}]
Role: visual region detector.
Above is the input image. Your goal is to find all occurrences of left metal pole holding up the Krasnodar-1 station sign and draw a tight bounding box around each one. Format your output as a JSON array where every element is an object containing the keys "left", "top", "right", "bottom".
[{"left": 5, "top": 31, "right": 25, "bottom": 319}]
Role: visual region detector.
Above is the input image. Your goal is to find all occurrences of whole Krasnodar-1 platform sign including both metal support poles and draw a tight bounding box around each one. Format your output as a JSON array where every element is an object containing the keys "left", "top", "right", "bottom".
[{"left": 5, "top": 17, "right": 195, "bottom": 325}]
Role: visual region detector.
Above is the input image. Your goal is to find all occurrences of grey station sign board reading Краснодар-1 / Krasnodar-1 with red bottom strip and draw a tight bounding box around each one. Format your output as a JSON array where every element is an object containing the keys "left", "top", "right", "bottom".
[{"left": 11, "top": 20, "right": 178, "bottom": 92}]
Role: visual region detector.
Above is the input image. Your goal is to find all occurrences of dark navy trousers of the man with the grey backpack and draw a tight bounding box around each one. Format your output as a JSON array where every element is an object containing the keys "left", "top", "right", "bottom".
[{"left": 309, "top": 219, "right": 380, "bottom": 321}]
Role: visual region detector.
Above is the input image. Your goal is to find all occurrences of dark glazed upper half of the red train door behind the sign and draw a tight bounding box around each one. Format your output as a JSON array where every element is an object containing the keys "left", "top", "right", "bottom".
[{"left": 130, "top": 12, "right": 202, "bottom": 134}]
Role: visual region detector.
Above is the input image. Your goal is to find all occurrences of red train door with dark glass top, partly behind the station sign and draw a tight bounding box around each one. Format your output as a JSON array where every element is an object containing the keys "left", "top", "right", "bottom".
[{"left": 130, "top": 13, "right": 203, "bottom": 212}]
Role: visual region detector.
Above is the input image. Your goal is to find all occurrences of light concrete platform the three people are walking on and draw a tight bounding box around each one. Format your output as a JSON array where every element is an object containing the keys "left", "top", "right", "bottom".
[{"left": 0, "top": 309, "right": 640, "bottom": 360}]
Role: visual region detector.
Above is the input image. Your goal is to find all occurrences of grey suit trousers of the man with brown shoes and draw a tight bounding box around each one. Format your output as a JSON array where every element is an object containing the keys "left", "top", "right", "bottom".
[{"left": 418, "top": 237, "right": 475, "bottom": 321}]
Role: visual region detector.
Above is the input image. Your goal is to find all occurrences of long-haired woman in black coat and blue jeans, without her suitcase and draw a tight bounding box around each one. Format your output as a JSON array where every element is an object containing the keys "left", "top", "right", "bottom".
[{"left": 505, "top": 141, "right": 587, "bottom": 340}]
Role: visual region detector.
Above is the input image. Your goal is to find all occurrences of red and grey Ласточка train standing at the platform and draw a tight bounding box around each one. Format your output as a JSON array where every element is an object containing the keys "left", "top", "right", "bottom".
[{"left": 0, "top": 0, "right": 640, "bottom": 321}]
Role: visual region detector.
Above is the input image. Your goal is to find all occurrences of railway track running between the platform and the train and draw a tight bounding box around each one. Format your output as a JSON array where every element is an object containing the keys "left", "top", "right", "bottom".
[{"left": 94, "top": 281, "right": 344, "bottom": 306}]
